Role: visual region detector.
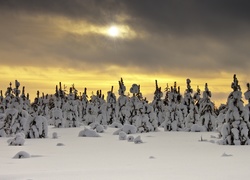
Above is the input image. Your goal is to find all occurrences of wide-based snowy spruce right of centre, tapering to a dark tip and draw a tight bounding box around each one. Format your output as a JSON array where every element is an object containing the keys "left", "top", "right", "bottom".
[{"left": 161, "top": 82, "right": 183, "bottom": 131}]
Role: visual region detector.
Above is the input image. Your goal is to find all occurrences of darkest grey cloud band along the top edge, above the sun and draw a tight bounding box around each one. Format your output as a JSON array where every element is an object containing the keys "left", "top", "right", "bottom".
[{"left": 0, "top": 0, "right": 250, "bottom": 35}]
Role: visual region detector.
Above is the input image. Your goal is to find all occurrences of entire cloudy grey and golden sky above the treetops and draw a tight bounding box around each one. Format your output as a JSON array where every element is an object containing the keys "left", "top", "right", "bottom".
[{"left": 0, "top": 0, "right": 250, "bottom": 105}]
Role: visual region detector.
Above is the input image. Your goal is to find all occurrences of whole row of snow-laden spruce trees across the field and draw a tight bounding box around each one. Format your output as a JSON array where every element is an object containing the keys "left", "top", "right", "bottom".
[{"left": 0, "top": 75, "right": 250, "bottom": 144}]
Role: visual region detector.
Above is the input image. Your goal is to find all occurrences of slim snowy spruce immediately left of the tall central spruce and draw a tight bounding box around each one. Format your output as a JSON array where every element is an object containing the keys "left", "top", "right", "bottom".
[{"left": 107, "top": 86, "right": 116, "bottom": 124}]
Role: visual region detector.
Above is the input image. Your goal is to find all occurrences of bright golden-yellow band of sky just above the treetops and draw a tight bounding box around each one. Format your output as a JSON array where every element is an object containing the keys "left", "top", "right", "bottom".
[{"left": 0, "top": 66, "right": 245, "bottom": 106}]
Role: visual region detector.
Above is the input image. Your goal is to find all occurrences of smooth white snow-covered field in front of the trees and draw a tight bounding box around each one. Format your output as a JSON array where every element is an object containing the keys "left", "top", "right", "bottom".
[{"left": 0, "top": 126, "right": 250, "bottom": 180}]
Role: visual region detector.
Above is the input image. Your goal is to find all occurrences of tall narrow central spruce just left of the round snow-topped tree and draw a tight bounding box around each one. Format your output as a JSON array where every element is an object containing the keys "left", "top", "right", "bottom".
[{"left": 116, "top": 78, "right": 128, "bottom": 124}]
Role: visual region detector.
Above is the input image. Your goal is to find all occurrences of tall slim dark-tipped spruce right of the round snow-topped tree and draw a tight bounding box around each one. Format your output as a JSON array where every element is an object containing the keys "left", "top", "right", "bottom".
[{"left": 151, "top": 80, "right": 164, "bottom": 125}]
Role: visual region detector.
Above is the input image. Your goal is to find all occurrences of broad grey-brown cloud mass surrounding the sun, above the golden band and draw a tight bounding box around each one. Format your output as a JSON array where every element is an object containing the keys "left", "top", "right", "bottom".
[{"left": 0, "top": 0, "right": 250, "bottom": 76}]
